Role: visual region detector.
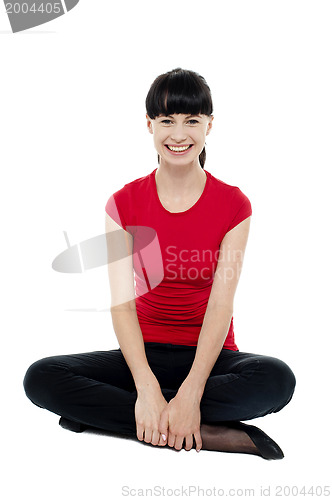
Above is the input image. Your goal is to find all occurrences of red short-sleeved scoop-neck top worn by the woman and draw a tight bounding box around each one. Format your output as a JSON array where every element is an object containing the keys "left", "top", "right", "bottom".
[{"left": 105, "top": 169, "right": 252, "bottom": 351}]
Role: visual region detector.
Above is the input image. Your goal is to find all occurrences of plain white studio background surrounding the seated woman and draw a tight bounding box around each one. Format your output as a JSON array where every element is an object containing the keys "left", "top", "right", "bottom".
[{"left": 0, "top": 0, "right": 332, "bottom": 500}]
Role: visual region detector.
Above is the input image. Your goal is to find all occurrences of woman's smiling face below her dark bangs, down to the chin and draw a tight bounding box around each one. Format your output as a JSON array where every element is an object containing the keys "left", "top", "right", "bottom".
[{"left": 146, "top": 113, "right": 214, "bottom": 164}]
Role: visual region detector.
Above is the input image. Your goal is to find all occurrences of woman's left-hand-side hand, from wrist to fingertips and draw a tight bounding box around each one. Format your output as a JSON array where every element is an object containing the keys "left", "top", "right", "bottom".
[{"left": 135, "top": 385, "right": 167, "bottom": 446}]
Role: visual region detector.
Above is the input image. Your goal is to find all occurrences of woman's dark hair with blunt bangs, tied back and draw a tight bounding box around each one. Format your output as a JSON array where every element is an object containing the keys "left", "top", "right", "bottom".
[{"left": 145, "top": 68, "right": 213, "bottom": 168}]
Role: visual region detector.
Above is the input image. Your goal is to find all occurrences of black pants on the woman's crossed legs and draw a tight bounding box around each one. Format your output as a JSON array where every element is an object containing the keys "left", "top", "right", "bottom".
[{"left": 23, "top": 342, "right": 295, "bottom": 435}]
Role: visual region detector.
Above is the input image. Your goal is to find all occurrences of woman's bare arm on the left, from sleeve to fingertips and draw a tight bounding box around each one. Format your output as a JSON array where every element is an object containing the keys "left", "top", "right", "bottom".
[{"left": 105, "top": 213, "right": 167, "bottom": 445}]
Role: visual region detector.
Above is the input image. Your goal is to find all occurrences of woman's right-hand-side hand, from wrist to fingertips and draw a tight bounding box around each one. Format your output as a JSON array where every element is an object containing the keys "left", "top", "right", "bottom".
[{"left": 159, "top": 387, "right": 202, "bottom": 451}]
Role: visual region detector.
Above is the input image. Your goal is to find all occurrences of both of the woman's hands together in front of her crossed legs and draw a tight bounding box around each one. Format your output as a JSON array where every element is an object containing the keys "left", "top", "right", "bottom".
[{"left": 135, "top": 388, "right": 202, "bottom": 451}]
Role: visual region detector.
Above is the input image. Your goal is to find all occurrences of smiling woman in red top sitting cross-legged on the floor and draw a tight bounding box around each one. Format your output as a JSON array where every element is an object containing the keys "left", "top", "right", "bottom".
[{"left": 24, "top": 68, "right": 295, "bottom": 459}]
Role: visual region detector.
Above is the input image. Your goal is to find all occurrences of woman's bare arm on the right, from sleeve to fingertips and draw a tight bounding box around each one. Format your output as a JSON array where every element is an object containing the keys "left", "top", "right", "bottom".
[{"left": 159, "top": 217, "right": 251, "bottom": 451}]
